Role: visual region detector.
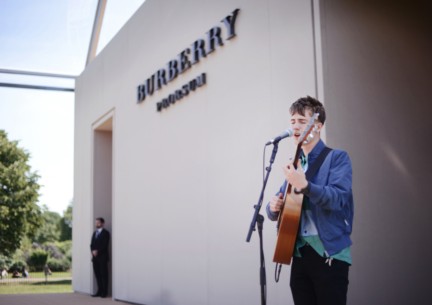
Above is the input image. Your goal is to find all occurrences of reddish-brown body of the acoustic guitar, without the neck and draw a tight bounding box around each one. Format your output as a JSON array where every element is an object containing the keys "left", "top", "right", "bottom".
[{"left": 273, "top": 192, "right": 303, "bottom": 265}]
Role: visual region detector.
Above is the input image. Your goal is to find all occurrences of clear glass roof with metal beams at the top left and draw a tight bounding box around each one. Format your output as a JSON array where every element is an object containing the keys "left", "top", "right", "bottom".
[{"left": 0, "top": 0, "right": 145, "bottom": 91}]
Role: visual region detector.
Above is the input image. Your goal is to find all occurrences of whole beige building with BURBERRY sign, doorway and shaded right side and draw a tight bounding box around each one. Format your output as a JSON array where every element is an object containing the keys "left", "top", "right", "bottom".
[{"left": 73, "top": 0, "right": 432, "bottom": 305}]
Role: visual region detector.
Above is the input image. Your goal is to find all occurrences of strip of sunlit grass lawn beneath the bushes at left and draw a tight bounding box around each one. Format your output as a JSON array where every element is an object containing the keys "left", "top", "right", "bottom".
[{"left": 0, "top": 272, "right": 72, "bottom": 294}]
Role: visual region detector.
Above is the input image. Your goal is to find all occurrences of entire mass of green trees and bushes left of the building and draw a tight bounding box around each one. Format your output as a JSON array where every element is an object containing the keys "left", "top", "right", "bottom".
[{"left": 0, "top": 137, "right": 72, "bottom": 271}]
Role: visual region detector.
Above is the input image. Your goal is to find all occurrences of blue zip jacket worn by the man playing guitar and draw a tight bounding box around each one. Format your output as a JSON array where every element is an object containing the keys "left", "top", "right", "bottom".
[{"left": 266, "top": 140, "right": 354, "bottom": 255}]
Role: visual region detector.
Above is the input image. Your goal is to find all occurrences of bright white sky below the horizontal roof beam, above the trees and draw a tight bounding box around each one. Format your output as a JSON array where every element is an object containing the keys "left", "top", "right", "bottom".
[{"left": 0, "top": 88, "right": 74, "bottom": 215}]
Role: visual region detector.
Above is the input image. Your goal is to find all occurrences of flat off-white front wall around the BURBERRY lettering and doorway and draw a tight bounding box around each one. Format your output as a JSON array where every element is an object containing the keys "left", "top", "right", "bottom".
[{"left": 73, "top": 0, "right": 317, "bottom": 305}]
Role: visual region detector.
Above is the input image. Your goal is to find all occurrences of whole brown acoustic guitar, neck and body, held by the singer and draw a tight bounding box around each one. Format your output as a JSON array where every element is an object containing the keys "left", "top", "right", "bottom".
[{"left": 273, "top": 113, "right": 318, "bottom": 265}]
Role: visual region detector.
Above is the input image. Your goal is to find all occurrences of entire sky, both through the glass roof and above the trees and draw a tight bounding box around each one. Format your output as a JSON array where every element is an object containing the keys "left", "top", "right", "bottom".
[{"left": 0, "top": 0, "right": 145, "bottom": 214}]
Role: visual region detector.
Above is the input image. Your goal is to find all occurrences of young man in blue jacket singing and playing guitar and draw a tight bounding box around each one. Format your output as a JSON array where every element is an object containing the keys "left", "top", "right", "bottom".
[{"left": 266, "top": 96, "right": 354, "bottom": 305}]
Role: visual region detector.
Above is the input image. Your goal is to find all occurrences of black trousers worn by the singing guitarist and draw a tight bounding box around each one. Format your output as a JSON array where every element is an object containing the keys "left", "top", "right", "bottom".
[{"left": 290, "top": 245, "right": 350, "bottom": 305}]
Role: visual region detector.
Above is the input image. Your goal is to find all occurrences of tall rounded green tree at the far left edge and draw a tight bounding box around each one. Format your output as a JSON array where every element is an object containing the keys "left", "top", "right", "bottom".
[{"left": 0, "top": 130, "right": 41, "bottom": 256}]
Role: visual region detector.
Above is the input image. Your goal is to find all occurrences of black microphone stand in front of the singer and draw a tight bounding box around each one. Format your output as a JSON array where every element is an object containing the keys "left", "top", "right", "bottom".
[{"left": 246, "top": 141, "right": 279, "bottom": 305}]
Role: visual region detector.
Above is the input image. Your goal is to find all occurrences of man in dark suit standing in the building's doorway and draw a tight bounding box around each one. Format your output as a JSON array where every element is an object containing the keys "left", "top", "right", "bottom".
[{"left": 90, "top": 217, "right": 110, "bottom": 298}]
